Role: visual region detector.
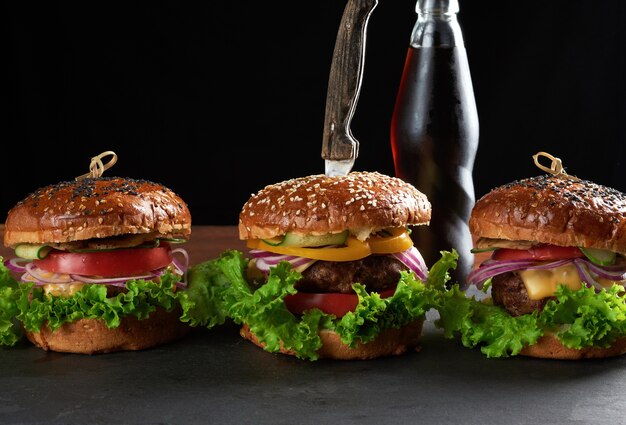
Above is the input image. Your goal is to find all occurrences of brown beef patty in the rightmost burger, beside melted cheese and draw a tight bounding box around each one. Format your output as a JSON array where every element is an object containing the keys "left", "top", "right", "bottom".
[{"left": 491, "top": 272, "right": 552, "bottom": 316}]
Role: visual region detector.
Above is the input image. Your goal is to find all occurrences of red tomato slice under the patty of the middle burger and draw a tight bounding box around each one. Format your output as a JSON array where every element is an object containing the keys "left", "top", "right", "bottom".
[{"left": 285, "top": 288, "right": 396, "bottom": 317}]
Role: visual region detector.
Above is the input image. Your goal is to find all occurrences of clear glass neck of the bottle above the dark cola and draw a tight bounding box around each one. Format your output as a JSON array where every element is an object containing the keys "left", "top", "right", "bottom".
[{"left": 411, "top": 0, "right": 463, "bottom": 47}]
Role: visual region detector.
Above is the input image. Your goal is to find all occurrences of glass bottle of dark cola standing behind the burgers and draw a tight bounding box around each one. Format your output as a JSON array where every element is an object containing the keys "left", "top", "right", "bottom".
[{"left": 391, "top": 0, "right": 478, "bottom": 284}]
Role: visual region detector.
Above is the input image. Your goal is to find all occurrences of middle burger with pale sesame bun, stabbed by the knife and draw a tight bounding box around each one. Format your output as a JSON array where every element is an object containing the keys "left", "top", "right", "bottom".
[{"left": 195, "top": 172, "right": 457, "bottom": 360}]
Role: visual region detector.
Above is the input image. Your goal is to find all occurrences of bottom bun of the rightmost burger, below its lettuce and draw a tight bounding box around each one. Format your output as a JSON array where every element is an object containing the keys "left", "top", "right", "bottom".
[{"left": 520, "top": 335, "right": 626, "bottom": 360}]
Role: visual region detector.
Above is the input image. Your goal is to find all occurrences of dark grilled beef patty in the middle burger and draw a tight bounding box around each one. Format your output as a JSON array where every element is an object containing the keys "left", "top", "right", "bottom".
[{"left": 295, "top": 255, "right": 409, "bottom": 294}]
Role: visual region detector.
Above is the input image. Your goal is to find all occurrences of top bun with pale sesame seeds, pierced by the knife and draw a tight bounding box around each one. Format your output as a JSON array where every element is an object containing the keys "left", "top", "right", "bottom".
[{"left": 239, "top": 172, "right": 431, "bottom": 240}]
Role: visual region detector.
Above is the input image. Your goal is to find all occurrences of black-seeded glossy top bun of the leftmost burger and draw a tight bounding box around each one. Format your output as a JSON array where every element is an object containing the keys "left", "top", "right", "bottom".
[{"left": 4, "top": 177, "right": 191, "bottom": 247}]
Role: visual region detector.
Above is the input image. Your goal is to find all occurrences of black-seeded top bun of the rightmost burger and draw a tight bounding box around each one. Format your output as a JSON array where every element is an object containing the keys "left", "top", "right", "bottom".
[{"left": 469, "top": 175, "right": 626, "bottom": 254}]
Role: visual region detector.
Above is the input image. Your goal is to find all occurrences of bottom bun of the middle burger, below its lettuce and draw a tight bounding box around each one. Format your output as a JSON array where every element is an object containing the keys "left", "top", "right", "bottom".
[{"left": 240, "top": 320, "right": 424, "bottom": 360}]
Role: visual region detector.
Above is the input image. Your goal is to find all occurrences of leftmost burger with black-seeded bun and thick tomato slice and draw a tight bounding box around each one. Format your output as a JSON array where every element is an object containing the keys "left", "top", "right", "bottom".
[{"left": 0, "top": 177, "right": 196, "bottom": 354}]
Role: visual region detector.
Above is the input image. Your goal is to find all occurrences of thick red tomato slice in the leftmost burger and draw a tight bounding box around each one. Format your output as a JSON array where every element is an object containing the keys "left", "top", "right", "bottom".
[{"left": 34, "top": 246, "right": 173, "bottom": 277}]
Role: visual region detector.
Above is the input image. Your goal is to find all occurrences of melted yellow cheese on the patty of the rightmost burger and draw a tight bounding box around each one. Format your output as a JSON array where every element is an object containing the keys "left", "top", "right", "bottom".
[{"left": 519, "top": 264, "right": 624, "bottom": 300}]
